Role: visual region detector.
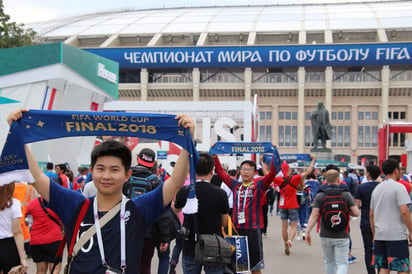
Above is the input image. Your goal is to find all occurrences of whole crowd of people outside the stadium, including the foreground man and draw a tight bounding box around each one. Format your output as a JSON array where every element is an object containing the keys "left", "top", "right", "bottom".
[{"left": 0, "top": 110, "right": 412, "bottom": 274}]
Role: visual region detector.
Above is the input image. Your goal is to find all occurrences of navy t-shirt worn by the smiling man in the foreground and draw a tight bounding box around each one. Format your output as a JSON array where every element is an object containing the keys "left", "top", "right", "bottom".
[{"left": 48, "top": 179, "right": 167, "bottom": 274}]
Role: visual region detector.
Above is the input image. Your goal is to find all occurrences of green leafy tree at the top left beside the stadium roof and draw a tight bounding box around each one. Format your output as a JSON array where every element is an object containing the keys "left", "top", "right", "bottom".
[{"left": 0, "top": 0, "right": 36, "bottom": 48}]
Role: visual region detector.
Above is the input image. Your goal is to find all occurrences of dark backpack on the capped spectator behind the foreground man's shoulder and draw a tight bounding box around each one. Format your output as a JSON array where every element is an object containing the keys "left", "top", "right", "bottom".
[{"left": 123, "top": 174, "right": 160, "bottom": 199}]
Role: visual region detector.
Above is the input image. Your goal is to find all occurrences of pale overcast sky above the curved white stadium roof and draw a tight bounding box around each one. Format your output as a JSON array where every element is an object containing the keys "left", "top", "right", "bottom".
[{"left": 4, "top": 0, "right": 388, "bottom": 24}]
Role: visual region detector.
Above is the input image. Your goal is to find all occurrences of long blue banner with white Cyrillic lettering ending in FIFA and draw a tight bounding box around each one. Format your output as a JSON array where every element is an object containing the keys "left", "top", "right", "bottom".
[{"left": 85, "top": 43, "right": 412, "bottom": 68}]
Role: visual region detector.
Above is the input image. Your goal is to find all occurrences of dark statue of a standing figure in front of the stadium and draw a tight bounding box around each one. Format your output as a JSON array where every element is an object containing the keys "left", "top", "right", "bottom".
[{"left": 310, "top": 102, "right": 332, "bottom": 149}]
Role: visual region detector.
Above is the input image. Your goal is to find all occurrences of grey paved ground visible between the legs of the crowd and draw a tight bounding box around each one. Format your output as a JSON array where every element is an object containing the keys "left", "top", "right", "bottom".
[{"left": 28, "top": 213, "right": 366, "bottom": 274}]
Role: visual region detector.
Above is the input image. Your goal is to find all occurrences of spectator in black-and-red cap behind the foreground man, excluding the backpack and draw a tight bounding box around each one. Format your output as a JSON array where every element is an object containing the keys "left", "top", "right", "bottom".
[{"left": 123, "top": 148, "right": 171, "bottom": 274}]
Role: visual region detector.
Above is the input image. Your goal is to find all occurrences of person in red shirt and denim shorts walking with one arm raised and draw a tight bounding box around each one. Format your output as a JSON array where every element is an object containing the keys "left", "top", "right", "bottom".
[{"left": 273, "top": 155, "right": 315, "bottom": 255}]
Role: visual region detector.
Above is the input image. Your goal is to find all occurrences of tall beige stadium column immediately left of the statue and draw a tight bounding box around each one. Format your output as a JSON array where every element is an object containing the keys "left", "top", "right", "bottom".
[{"left": 298, "top": 67, "right": 305, "bottom": 153}]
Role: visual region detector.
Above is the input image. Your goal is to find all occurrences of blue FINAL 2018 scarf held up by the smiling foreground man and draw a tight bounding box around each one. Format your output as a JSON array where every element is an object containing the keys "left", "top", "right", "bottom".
[{"left": 0, "top": 110, "right": 199, "bottom": 212}]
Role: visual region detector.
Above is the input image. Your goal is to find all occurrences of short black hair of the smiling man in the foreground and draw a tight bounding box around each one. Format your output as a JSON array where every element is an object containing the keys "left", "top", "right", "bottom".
[{"left": 90, "top": 140, "right": 132, "bottom": 171}]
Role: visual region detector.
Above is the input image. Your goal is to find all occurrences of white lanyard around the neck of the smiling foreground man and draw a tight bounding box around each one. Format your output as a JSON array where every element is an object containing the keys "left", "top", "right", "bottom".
[{"left": 93, "top": 195, "right": 127, "bottom": 273}]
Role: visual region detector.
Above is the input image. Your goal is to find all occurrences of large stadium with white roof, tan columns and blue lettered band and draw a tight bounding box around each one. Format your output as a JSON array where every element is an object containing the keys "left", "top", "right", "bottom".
[{"left": 28, "top": 1, "right": 412, "bottom": 163}]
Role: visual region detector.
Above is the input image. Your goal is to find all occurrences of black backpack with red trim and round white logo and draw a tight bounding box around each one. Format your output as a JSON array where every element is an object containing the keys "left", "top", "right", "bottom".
[{"left": 317, "top": 188, "right": 350, "bottom": 233}]
